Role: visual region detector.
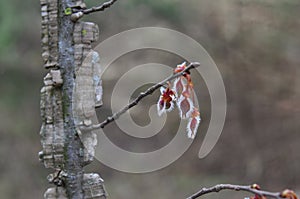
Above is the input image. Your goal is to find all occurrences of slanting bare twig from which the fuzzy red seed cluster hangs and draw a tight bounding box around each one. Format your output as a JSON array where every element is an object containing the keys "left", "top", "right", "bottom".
[{"left": 81, "top": 62, "right": 200, "bottom": 130}]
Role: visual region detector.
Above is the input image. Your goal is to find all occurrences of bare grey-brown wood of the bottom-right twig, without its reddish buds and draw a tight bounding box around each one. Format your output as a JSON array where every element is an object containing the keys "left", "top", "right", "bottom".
[{"left": 187, "top": 184, "right": 284, "bottom": 199}]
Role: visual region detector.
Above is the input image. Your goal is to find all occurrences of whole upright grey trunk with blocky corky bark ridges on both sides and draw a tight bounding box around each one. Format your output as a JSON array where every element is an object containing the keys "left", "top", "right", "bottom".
[{"left": 39, "top": 0, "right": 106, "bottom": 199}]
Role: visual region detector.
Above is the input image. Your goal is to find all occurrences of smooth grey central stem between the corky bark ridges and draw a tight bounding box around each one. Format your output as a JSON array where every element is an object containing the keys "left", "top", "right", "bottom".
[{"left": 58, "top": 0, "right": 83, "bottom": 198}]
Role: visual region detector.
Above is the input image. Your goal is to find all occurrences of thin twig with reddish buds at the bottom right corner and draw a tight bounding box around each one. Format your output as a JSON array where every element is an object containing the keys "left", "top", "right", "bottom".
[{"left": 187, "top": 184, "right": 297, "bottom": 199}]
